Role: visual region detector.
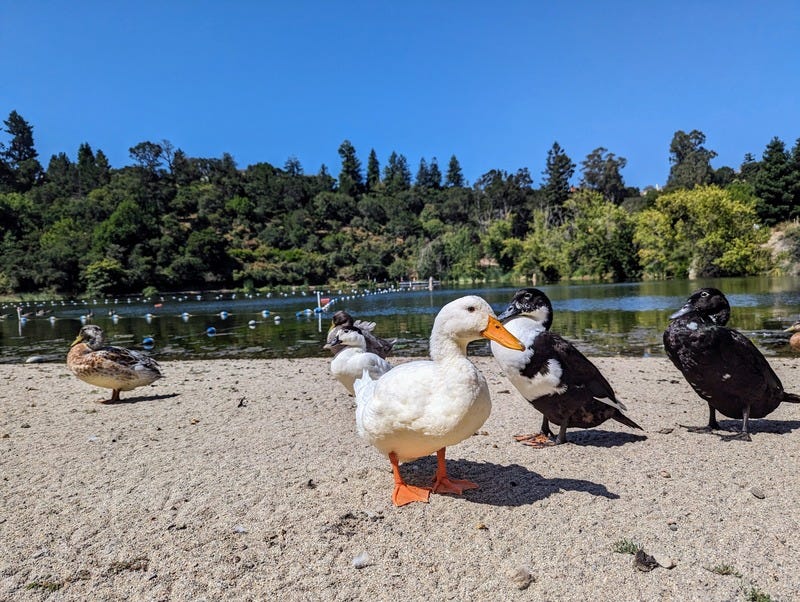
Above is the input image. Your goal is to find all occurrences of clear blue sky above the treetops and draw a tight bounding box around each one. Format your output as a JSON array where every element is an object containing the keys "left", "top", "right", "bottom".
[{"left": 0, "top": 0, "right": 800, "bottom": 187}]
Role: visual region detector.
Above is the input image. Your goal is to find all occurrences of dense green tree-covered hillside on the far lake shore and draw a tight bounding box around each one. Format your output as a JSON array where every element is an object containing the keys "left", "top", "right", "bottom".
[{"left": 0, "top": 111, "right": 800, "bottom": 294}]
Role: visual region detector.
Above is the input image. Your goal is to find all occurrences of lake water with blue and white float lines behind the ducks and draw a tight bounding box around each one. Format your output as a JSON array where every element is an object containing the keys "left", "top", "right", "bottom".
[{"left": 0, "top": 277, "right": 800, "bottom": 363}]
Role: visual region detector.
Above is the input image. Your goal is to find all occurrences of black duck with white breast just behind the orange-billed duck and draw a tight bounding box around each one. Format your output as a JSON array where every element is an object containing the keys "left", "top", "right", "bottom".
[{"left": 492, "top": 288, "right": 642, "bottom": 447}]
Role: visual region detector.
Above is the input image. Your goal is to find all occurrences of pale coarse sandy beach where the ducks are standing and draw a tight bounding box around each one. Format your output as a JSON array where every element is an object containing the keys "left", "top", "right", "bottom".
[{"left": 0, "top": 357, "right": 800, "bottom": 601}]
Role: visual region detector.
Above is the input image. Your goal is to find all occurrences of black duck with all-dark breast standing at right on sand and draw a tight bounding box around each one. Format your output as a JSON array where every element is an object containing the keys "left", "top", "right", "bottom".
[{"left": 664, "top": 288, "right": 800, "bottom": 441}]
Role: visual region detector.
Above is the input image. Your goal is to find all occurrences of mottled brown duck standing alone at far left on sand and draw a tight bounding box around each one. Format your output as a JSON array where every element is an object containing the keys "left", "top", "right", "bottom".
[{"left": 67, "top": 324, "right": 163, "bottom": 403}]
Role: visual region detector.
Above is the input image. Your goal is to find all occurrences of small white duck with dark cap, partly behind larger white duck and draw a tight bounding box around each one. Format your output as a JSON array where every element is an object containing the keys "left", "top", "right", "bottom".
[{"left": 324, "top": 326, "right": 392, "bottom": 395}]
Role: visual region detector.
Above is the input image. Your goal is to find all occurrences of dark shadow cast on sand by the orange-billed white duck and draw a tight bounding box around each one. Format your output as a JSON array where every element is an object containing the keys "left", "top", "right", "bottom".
[{"left": 401, "top": 456, "right": 619, "bottom": 506}]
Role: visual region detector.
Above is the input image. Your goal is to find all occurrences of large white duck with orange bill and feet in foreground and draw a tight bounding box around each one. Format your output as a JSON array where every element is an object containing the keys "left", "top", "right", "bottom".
[{"left": 355, "top": 296, "right": 525, "bottom": 506}]
